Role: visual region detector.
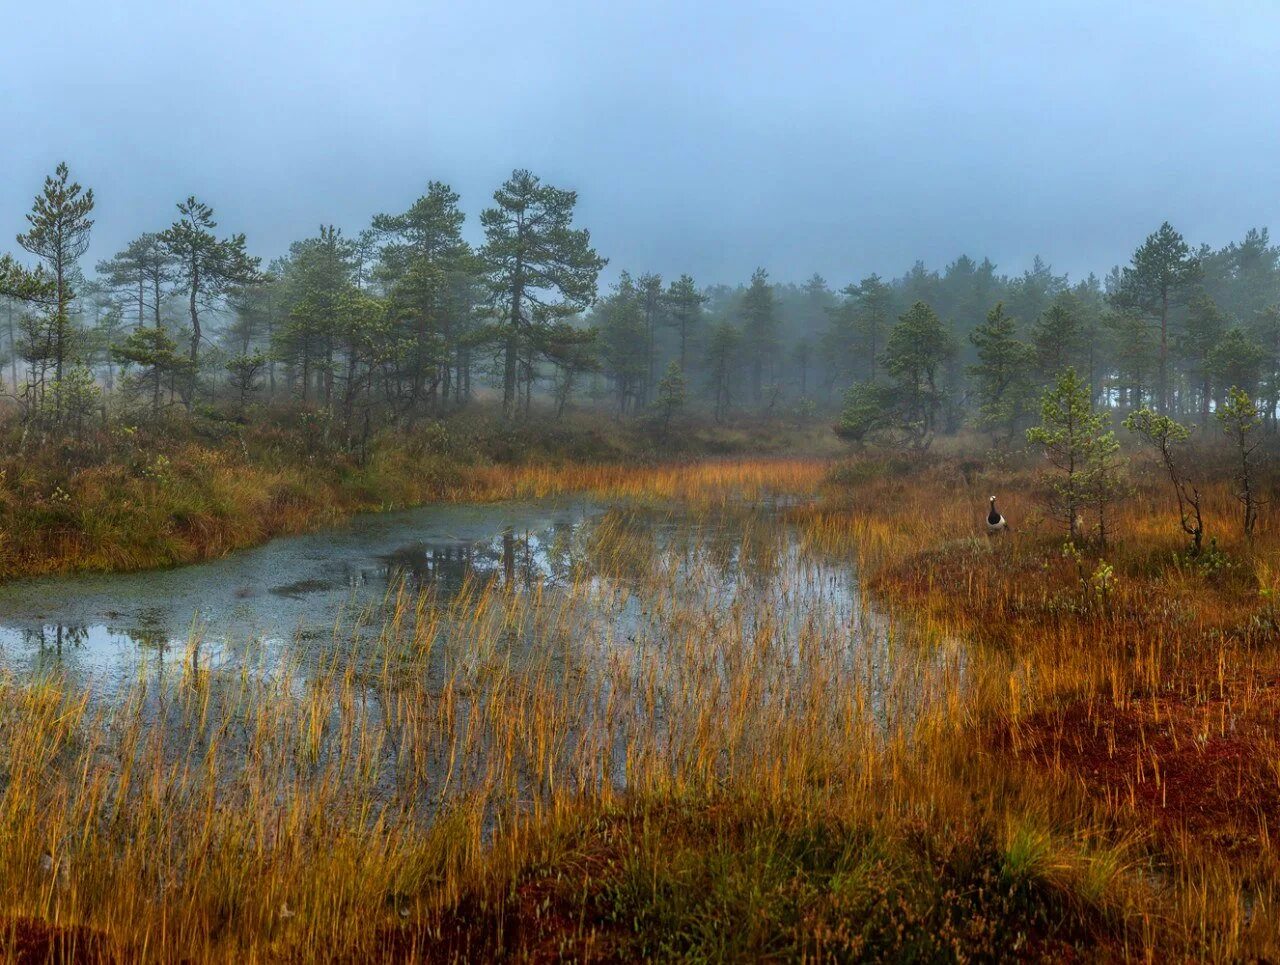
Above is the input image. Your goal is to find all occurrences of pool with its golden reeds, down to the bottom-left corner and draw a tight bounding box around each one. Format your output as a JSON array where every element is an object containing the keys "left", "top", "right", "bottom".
[{"left": 0, "top": 483, "right": 964, "bottom": 961}]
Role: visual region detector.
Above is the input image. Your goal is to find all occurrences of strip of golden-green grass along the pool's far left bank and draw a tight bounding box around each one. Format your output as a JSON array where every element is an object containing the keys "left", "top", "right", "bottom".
[{"left": 0, "top": 427, "right": 820, "bottom": 580}]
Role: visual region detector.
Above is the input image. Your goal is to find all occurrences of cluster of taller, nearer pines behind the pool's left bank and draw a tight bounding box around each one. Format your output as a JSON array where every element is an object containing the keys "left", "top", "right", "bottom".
[{"left": 0, "top": 164, "right": 605, "bottom": 433}]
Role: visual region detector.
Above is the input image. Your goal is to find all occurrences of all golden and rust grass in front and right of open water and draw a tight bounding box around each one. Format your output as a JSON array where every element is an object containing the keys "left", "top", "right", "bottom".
[{"left": 0, "top": 450, "right": 1280, "bottom": 961}]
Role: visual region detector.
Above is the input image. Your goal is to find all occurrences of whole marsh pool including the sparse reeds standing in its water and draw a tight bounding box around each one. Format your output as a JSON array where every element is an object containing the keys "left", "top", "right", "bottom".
[{"left": 0, "top": 500, "right": 951, "bottom": 825}]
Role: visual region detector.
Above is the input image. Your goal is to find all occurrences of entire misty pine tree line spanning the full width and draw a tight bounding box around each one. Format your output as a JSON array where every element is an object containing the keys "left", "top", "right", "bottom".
[{"left": 0, "top": 164, "right": 1280, "bottom": 448}]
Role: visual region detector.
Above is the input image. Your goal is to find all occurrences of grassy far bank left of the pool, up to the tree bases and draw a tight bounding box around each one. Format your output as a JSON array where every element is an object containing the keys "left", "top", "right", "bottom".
[{"left": 0, "top": 399, "right": 829, "bottom": 580}]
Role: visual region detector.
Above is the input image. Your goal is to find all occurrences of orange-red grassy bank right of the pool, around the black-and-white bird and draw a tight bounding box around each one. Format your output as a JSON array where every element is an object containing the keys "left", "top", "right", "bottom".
[{"left": 804, "top": 450, "right": 1280, "bottom": 959}]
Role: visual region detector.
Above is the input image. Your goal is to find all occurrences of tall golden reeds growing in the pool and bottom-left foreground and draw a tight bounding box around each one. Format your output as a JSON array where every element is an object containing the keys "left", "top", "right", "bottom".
[{"left": 0, "top": 491, "right": 952, "bottom": 960}]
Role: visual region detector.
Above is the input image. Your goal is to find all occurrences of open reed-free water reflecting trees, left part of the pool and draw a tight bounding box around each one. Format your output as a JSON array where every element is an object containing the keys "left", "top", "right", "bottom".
[{"left": 0, "top": 502, "right": 604, "bottom": 689}]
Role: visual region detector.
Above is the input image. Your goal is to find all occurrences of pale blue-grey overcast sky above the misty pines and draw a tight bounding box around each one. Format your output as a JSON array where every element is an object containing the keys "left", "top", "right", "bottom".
[{"left": 0, "top": 0, "right": 1280, "bottom": 285}]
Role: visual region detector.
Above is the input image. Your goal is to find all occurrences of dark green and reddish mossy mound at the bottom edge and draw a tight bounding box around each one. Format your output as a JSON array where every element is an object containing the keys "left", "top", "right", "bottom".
[{"left": 375, "top": 802, "right": 1107, "bottom": 962}]
